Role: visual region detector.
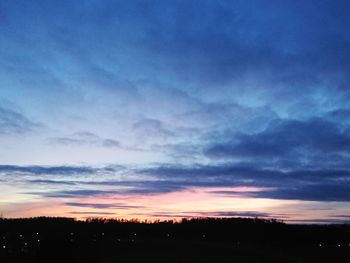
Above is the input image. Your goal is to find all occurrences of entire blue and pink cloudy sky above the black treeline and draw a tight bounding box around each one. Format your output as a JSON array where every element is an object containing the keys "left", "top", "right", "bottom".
[{"left": 0, "top": 0, "right": 350, "bottom": 223}]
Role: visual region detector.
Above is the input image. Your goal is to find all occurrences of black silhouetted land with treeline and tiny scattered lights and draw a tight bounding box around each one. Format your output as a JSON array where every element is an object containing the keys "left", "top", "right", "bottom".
[{"left": 0, "top": 218, "right": 350, "bottom": 263}]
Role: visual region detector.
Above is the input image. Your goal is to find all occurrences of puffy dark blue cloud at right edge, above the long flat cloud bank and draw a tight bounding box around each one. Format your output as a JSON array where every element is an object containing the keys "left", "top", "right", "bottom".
[{"left": 204, "top": 118, "right": 350, "bottom": 169}]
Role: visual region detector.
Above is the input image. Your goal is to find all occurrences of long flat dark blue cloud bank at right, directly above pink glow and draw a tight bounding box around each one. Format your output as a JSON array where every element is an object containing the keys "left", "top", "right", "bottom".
[{"left": 142, "top": 163, "right": 350, "bottom": 202}]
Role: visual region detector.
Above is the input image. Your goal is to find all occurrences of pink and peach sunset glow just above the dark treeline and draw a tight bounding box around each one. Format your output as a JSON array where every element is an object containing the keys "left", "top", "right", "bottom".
[{"left": 2, "top": 187, "right": 348, "bottom": 225}]
